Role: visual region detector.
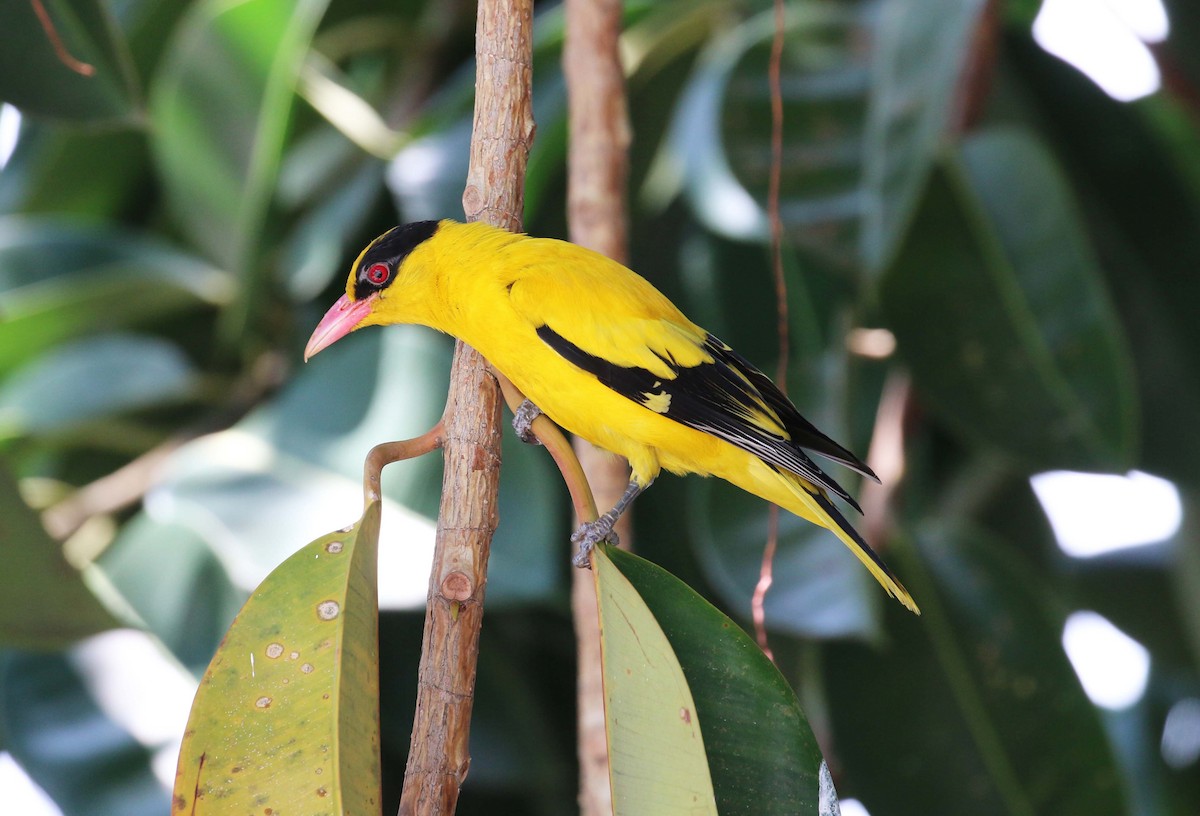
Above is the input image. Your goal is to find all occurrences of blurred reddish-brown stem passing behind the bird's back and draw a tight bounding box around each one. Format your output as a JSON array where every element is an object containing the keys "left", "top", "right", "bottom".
[{"left": 563, "top": 0, "right": 631, "bottom": 816}]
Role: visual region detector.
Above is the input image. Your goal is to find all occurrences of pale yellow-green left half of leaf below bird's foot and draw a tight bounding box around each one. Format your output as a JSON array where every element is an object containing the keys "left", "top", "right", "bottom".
[{"left": 594, "top": 547, "right": 716, "bottom": 816}]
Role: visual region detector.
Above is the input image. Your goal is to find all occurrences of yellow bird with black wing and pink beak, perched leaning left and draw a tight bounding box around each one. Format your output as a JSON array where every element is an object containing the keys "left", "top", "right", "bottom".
[{"left": 305, "top": 221, "right": 919, "bottom": 613}]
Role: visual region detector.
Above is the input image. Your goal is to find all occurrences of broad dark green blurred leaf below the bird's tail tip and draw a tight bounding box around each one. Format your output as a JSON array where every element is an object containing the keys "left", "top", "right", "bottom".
[{"left": 824, "top": 528, "right": 1128, "bottom": 816}]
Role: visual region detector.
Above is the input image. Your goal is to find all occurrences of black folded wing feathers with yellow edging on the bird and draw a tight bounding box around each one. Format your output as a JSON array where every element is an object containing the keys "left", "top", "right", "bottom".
[{"left": 538, "top": 325, "right": 878, "bottom": 512}]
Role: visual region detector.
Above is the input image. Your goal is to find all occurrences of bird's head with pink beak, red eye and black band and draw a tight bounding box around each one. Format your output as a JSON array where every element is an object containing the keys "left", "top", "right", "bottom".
[{"left": 304, "top": 221, "right": 439, "bottom": 361}]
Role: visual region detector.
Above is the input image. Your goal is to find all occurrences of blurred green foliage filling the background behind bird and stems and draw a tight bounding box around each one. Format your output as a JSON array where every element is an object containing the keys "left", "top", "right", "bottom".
[{"left": 0, "top": 0, "right": 1200, "bottom": 816}]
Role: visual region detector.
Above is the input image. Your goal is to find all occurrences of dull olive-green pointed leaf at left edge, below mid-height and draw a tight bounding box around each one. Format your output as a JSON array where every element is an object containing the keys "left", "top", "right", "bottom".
[{"left": 0, "top": 461, "right": 120, "bottom": 649}]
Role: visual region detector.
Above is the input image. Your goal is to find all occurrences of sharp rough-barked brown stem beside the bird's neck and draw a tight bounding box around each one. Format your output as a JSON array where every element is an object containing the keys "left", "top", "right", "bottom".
[{"left": 400, "top": 0, "right": 534, "bottom": 816}]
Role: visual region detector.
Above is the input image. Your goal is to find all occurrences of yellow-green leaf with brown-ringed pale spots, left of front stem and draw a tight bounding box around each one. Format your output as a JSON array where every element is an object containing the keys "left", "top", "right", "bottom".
[{"left": 172, "top": 503, "right": 380, "bottom": 816}]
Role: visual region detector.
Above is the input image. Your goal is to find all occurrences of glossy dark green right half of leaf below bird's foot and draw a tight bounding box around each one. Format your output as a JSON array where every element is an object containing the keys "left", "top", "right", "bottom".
[{"left": 596, "top": 547, "right": 836, "bottom": 816}]
